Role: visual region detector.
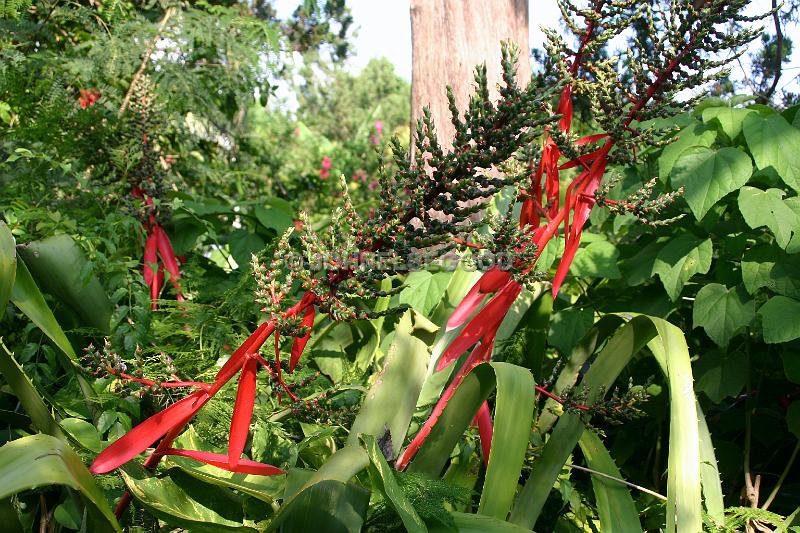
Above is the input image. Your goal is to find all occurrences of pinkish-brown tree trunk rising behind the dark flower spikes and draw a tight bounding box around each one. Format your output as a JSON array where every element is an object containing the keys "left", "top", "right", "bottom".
[{"left": 411, "top": 0, "right": 531, "bottom": 148}]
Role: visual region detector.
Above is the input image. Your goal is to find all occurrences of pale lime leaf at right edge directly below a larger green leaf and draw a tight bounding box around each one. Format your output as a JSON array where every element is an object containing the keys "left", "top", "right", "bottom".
[{"left": 739, "top": 187, "right": 800, "bottom": 248}]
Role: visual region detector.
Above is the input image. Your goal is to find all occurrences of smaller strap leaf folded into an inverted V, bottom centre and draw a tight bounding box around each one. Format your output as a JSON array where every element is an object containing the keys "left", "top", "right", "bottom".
[{"left": 409, "top": 363, "right": 535, "bottom": 520}]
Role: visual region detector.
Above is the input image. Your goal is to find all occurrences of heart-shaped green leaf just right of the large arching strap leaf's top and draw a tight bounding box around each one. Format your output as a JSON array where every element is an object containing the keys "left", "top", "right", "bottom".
[{"left": 692, "top": 283, "right": 756, "bottom": 346}]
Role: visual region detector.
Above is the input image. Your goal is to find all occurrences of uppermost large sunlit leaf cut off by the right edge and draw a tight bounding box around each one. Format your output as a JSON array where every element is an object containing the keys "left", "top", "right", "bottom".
[{"left": 742, "top": 113, "right": 800, "bottom": 192}]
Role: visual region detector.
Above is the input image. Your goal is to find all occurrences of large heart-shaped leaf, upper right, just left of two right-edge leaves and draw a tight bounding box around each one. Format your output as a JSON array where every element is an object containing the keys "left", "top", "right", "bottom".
[{"left": 670, "top": 145, "right": 753, "bottom": 220}]
